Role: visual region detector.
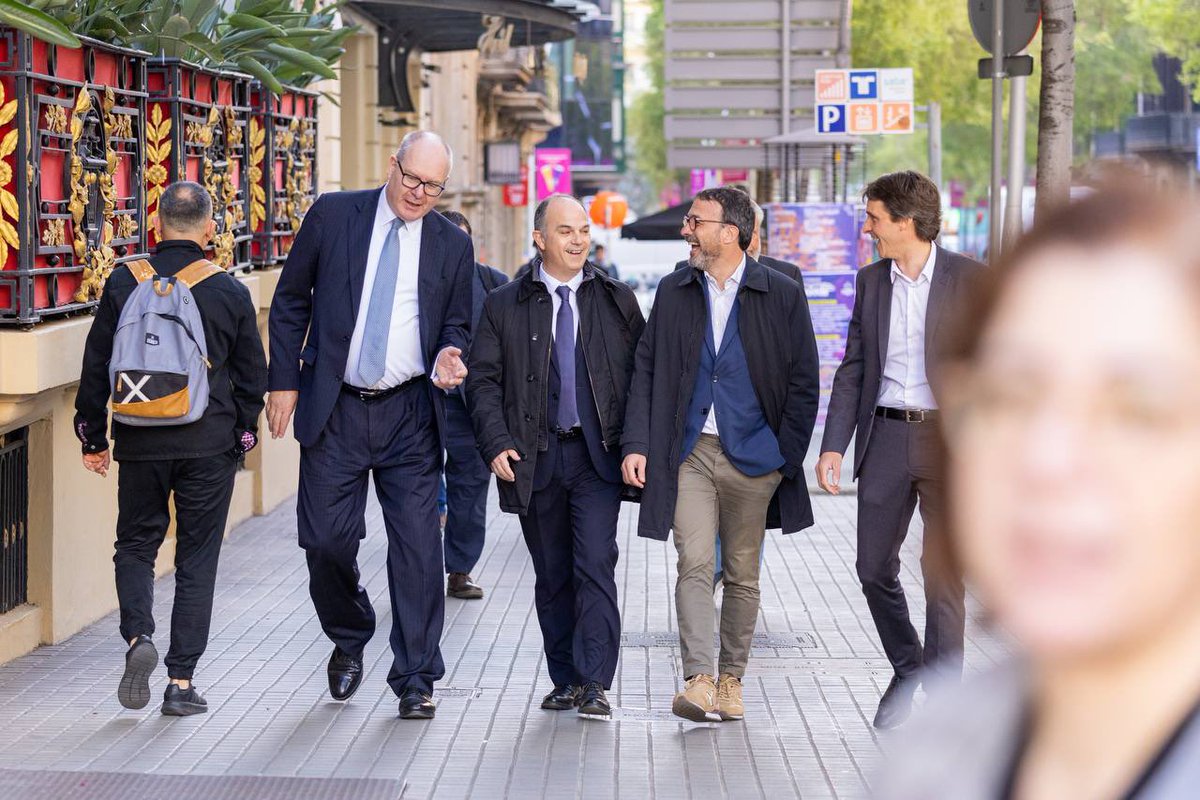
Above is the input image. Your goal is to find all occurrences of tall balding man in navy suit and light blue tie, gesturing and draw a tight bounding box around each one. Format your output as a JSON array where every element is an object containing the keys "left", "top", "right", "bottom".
[{"left": 266, "top": 131, "right": 475, "bottom": 720}]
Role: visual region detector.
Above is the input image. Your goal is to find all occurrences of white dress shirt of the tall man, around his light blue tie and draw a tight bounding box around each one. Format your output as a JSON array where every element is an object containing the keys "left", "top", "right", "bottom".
[{"left": 344, "top": 190, "right": 433, "bottom": 389}]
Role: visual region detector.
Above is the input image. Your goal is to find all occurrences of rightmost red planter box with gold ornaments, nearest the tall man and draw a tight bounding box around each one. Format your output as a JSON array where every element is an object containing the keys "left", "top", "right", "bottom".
[{"left": 250, "top": 80, "right": 317, "bottom": 266}]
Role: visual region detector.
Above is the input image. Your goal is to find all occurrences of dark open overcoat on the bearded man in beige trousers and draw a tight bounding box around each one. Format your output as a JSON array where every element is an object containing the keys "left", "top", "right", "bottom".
[{"left": 620, "top": 257, "right": 820, "bottom": 540}]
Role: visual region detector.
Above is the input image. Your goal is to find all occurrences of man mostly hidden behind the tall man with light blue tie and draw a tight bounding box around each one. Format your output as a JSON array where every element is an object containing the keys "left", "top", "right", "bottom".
[{"left": 442, "top": 211, "right": 509, "bottom": 600}]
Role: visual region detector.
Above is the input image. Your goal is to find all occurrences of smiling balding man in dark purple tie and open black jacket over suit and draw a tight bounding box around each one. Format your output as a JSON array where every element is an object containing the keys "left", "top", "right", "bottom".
[{"left": 467, "top": 194, "right": 644, "bottom": 717}]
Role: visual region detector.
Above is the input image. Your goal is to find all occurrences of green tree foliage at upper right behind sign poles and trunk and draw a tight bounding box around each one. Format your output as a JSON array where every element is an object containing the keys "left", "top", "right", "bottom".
[{"left": 851, "top": 0, "right": 1156, "bottom": 198}]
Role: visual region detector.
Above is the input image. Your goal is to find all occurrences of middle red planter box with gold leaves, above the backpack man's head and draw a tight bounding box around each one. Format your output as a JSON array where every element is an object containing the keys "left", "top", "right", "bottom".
[{"left": 145, "top": 59, "right": 252, "bottom": 271}]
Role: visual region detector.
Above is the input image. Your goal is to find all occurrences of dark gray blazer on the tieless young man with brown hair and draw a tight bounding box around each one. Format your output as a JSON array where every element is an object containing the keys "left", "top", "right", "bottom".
[{"left": 821, "top": 247, "right": 984, "bottom": 479}]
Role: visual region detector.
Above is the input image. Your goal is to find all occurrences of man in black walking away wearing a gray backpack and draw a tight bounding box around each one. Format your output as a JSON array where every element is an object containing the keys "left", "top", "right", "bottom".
[{"left": 74, "top": 181, "right": 266, "bottom": 716}]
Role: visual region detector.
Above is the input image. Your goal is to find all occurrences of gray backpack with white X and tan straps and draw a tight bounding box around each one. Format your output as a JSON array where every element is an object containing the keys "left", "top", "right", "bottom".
[{"left": 108, "top": 259, "right": 224, "bottom": 426}]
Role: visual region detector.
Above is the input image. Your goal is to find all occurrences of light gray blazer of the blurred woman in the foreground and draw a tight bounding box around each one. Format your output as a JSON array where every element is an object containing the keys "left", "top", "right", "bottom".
[{"left": 871, "top": 661, "right": 1200, "bottom": 800}]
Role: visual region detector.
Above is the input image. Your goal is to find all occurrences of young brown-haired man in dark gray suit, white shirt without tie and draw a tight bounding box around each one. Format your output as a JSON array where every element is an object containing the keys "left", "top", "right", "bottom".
[{"left": 816, "top": 172, "right": 983, "bottom": 728}]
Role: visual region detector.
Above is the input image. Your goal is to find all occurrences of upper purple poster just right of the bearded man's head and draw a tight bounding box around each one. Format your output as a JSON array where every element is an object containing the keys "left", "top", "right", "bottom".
[{"left": 767, "top": 203, "right": 870, "bottom": 272}]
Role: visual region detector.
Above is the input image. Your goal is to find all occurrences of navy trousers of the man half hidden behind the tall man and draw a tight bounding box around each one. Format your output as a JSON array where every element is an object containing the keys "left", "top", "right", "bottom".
[{"left": 443, "top": 393, "right": 492, "bottom": 572}]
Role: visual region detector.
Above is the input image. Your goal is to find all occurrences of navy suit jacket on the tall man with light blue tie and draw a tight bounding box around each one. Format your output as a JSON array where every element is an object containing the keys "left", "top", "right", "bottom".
[{"left": 268, "top": 188, "right": 475, "bottom": 447}]
